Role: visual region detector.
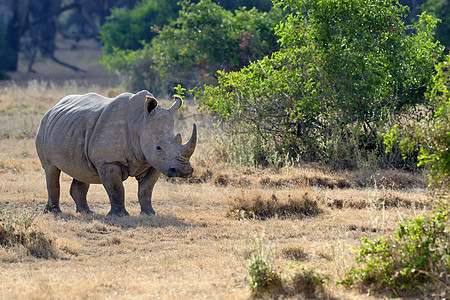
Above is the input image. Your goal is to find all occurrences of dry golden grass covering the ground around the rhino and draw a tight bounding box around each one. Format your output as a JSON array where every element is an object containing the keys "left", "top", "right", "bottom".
[{"left": 0, "top": 83, "right": 436, "bottom": 299}]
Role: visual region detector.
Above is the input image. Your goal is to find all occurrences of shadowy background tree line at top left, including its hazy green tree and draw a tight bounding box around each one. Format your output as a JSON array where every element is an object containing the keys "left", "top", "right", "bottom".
[{"left": 0, "top": 0, "right": 271, "bottom": 76}]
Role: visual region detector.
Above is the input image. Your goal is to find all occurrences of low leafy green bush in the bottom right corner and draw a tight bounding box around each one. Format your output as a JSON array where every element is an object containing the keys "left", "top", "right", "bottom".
[{"left": 338, "top": 206, "right": 450, "bottom": 296}]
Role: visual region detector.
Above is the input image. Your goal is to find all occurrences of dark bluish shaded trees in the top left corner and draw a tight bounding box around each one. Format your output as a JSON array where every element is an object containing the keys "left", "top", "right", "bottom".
[{"left": 0, "top": 0, "right": 136, "bottom": 71}]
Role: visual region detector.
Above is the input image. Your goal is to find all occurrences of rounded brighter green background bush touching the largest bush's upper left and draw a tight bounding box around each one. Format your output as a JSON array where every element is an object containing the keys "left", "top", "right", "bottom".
[{"left": 153, "top": 0, "right": 281, "bottom": 80}]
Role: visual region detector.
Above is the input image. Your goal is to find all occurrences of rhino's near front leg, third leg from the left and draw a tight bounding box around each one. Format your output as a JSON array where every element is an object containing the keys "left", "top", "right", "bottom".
[{"left": 98, "top": 164, "right": 129, "bottom": 216}]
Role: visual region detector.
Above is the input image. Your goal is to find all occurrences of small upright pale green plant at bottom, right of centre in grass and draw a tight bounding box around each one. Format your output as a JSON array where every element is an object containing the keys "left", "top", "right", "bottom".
[{"left": 246, "top": 236, "right": 283, "bottom": 295}]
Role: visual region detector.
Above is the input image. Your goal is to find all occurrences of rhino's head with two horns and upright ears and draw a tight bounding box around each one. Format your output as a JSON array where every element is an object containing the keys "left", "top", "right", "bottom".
[{"left": 140, "top": 96, "right": 197, "bottom": 177}]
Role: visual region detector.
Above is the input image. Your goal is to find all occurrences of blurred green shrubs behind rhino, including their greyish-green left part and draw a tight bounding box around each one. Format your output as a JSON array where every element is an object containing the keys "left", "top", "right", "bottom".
[{"left": 103, "top": 0, "right": 283, "bottom": 91}]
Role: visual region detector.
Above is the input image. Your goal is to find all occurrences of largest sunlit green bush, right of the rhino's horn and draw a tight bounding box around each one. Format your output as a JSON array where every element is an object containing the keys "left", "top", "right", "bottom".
[{"left": 197, "top": 0, "right": 441, "bottom": 167}]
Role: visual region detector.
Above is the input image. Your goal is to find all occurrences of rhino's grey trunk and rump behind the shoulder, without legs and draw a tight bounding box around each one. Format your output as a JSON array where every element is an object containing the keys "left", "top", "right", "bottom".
[{"left": 36, "top": 93, "right": 131, "bottom": 183}]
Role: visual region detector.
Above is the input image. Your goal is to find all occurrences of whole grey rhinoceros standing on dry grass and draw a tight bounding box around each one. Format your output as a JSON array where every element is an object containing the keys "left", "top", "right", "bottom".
[{"left": 36, "top": 90, "right": 197, "bottom": 216}]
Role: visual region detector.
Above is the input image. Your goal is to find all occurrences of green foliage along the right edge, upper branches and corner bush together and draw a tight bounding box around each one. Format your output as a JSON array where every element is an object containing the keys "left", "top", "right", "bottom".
[{"left": 341, "top": 51, "right": 450, "bottom": 298}]
